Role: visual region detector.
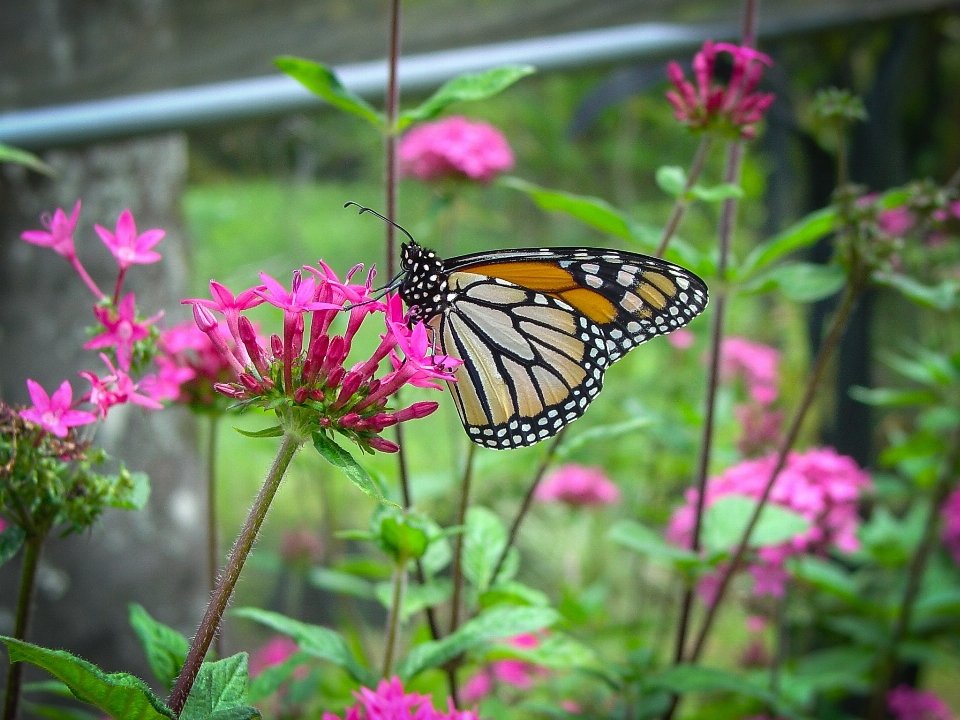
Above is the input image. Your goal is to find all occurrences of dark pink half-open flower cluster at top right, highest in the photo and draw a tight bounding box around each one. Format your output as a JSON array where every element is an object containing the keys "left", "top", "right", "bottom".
[{"left": 667, "top": 40, "right": 774, "bottom": 140}]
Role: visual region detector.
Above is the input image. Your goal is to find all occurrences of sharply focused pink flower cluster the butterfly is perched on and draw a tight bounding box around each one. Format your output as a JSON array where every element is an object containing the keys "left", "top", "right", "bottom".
[{"left": 183, "top": 268, "right": 460, "bottom": 452}]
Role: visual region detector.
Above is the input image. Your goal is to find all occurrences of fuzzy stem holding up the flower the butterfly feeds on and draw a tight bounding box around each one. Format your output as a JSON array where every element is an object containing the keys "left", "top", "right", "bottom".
[{"left": 168, "top": 434, "right": 303, "bottom": 717}]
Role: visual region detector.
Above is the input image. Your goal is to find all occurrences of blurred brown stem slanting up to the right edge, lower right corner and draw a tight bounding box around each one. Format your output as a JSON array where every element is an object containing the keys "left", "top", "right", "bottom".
[{"left": 867, "top": 432, "right": 960, "bottom": 720}]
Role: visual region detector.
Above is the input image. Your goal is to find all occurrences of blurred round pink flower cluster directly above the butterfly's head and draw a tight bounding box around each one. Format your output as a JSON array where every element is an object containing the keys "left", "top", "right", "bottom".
[{"left": 397, "top": 115, "right": 513, "bottom": 183}]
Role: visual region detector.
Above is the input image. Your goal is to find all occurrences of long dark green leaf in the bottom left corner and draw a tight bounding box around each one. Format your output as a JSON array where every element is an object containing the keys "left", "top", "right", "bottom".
[{"left": 0, "top": 636, "right": 176, "bottom": 720}]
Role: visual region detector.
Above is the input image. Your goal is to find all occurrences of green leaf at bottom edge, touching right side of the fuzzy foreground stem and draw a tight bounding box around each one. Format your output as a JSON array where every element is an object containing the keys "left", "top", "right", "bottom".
[{"left": 180, "top": 653, "right": 260, "bottom": 720}]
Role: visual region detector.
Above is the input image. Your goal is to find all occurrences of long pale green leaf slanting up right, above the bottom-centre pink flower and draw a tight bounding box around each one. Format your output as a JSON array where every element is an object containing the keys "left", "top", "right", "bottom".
[{"left": 396, "top": 605, "right": 560, "bottom": 681}]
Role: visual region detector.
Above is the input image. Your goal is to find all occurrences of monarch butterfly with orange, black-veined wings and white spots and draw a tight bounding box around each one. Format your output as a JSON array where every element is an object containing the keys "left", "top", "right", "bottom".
[{"left": 399, "top": 242, "right": 707, "bottom": 449}]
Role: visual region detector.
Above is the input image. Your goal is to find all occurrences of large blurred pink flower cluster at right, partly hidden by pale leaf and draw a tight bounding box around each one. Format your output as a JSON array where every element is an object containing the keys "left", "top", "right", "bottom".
[{"left": 667, "top": 448, "right": 872, "bottom": 602}]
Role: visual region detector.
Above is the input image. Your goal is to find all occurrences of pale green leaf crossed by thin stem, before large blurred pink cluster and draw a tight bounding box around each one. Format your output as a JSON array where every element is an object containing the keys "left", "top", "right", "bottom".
[{"left": 703, "top": 495, "right": 810, "bottom": 552}]
